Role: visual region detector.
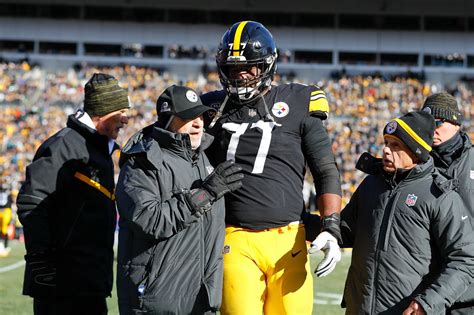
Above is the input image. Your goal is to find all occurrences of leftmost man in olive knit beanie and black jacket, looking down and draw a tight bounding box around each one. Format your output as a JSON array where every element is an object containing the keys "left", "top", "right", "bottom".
[{"left": 17, "top": 73, "right": 130, "bottom": 314}]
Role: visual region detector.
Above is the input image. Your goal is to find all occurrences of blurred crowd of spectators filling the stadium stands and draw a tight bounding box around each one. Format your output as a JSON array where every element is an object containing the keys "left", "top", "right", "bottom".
[{"left": 0, "top": 62, "right": 474, "bottom": 206}]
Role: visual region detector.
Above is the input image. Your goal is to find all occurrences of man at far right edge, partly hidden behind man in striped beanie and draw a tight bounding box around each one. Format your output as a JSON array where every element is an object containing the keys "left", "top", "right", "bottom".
[{"left": 423, "top": 92, "right": 474, "bottom": 315}]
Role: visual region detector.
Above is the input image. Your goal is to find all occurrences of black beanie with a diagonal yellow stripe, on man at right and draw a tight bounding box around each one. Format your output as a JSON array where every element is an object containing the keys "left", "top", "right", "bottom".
[{"left": 383, "top": 111, "right": 435, "bottom": 162}]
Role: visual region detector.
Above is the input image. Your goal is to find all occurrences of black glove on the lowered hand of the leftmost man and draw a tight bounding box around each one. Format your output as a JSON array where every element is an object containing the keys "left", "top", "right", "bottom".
[{"left": 25, "top": 252, "right": 56, "bottom": 296}]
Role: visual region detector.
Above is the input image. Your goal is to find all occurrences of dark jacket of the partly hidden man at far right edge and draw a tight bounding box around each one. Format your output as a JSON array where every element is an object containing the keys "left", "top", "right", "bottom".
[{"left": 432, "top": 132, "right": 474, "bottom": 307}]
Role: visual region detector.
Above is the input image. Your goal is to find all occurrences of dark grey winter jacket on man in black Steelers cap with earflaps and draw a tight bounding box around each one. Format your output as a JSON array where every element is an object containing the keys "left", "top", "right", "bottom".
[{"left": 117, "top": 125, "right": 225, "bottom": 314}]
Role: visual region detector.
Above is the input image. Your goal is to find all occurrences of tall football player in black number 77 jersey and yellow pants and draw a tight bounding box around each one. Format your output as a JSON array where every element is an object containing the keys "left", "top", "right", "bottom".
[{"left": 202, "top": 21, "right": 341, "bottom": 314}]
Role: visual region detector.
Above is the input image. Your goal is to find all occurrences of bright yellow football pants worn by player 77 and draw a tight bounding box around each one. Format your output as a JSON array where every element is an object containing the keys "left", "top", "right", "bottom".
[{"left": 221, "top": 223, "right": 313, "bottom": 315}]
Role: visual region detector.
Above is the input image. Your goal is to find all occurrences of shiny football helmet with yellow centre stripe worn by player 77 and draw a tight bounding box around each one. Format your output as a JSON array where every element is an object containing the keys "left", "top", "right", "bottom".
[{"left": 216, "top": 21, "right": 277, "bottom": 103}]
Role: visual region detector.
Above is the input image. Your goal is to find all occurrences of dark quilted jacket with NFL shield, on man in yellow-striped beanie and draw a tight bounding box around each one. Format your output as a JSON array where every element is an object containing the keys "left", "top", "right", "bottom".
[{"left": 341, "top": 156, "right": 474, "bottom": 314}]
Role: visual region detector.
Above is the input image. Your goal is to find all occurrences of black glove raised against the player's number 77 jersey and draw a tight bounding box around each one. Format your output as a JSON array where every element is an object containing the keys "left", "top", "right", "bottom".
[{"left": 186, "top": 160, "right": 244, "bottom": 213}]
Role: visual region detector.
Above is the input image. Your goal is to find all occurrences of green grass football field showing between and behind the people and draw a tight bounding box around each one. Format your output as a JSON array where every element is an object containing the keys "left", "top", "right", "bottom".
[{"left": 0, "top": 241, "right": 350, "bottom": 315}]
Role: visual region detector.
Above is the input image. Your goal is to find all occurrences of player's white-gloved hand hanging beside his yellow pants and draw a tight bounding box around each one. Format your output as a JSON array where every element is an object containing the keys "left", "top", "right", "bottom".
[{"left": 308, "top": 232, "right": 341, "bottom": 277}]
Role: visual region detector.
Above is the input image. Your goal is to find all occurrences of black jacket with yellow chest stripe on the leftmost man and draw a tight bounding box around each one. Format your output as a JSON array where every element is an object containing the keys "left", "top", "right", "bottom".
[{"left": 17, "top": 115, "right": 117, "bottom": 297}]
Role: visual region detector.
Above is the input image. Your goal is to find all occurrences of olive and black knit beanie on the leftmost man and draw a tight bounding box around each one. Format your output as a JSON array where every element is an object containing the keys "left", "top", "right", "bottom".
[{"left": 84, "top": 73, "right": 130, "bottom": 117}]
